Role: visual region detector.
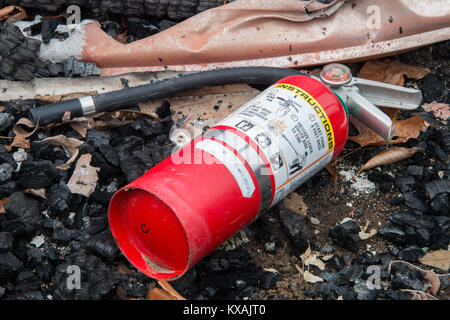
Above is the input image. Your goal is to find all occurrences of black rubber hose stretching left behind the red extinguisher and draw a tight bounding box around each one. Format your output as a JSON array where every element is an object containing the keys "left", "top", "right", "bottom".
[{"left": 30, "top": 67, "right": 309, "bottom": 126}]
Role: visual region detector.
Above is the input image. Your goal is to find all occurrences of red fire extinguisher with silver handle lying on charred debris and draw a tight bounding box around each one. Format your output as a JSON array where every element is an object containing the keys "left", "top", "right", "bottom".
[{"left": 105, "top": 64, "right": 421, "bottom": 280}]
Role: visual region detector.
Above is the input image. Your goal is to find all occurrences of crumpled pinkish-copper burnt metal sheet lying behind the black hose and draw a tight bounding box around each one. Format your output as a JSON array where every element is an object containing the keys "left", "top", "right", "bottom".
[{"left": 35, "top": 0, "right": 450, "bottom": 75}]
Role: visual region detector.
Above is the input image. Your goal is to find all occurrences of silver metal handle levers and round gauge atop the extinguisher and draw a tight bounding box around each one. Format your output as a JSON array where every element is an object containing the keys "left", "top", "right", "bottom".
[{"left": 320, "top": 64, "right": 422, "bottom": 143}]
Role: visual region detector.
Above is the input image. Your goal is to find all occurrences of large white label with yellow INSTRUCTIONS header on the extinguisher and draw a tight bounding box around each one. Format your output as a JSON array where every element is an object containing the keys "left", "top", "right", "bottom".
[{"left": 218, "top": 83, "right": 335, "bottom": 205}]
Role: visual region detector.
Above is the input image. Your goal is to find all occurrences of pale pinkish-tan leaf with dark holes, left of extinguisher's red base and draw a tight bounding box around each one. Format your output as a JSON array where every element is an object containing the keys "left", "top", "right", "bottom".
[{"left": 67, "top": 153, "right": 100, "bottom": 197}]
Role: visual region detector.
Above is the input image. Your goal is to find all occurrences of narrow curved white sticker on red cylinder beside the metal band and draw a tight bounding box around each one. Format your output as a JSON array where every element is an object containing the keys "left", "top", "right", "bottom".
[{"left": 195, "top": 139, "right": 255, "bottom": 198}]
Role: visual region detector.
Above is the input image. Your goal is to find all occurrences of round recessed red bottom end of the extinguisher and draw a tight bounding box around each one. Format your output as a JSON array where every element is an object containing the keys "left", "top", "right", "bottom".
[{"left": 109, "top": 188, "right": 189, "bottom": 280}]
